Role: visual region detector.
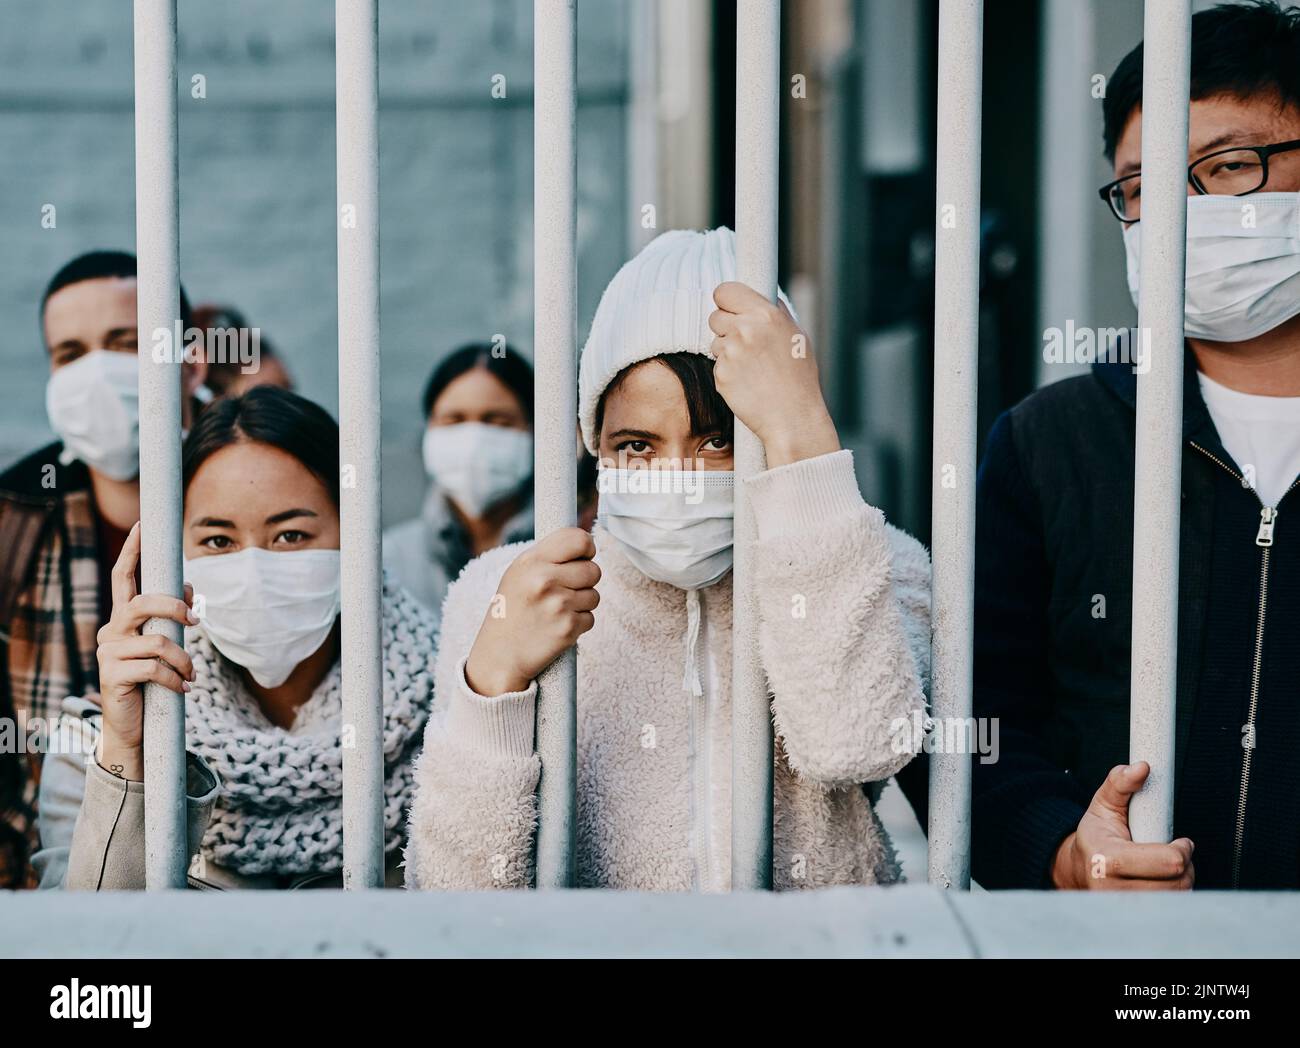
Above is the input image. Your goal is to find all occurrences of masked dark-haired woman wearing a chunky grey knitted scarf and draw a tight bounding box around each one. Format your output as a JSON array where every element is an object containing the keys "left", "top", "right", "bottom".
[{"left": 33, "top": 386, "right": 437, "bottom": 889}]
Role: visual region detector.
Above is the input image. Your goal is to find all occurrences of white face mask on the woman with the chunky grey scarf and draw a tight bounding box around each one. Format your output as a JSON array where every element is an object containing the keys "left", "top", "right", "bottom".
[{"left": 185, "top": 547, "right": 339, "bottom": 688}]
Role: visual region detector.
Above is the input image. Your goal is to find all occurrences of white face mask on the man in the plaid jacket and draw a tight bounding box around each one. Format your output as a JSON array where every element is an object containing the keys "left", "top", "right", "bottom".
[{"left": 46, "top": 350, "right": 140, "bottom": 480}]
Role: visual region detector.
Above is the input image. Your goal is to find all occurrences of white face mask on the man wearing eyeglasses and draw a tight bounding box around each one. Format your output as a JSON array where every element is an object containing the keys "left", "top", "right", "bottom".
[{"left": 1125, "top": 192, "right": 1300, "bottom": 342}]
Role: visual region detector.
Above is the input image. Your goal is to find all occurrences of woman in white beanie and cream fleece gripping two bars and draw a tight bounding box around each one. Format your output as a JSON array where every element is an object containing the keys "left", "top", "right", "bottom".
[{"left": 406, "top": 229, "right": 930, "bottom": 891}]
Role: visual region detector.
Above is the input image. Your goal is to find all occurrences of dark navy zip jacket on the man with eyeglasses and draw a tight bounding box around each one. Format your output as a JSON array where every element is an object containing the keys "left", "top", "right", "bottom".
[{"left": 900, "top": 355, "right": 1300, "bottom": 888}]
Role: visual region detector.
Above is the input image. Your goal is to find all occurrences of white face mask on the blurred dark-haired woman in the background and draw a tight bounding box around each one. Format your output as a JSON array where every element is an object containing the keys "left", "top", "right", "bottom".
[{"left": 424, "top": 423, "right": 533, "bottom": 516}]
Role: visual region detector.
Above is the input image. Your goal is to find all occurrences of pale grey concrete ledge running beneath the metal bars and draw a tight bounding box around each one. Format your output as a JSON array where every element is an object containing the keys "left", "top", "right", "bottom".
[{"left": 0, "top": 885, "right": 1300, "bottom": 958}]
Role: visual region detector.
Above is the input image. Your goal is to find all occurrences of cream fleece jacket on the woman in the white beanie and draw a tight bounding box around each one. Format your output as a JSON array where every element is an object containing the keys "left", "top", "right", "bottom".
[{"left": 406, "top": 451, "right": 930, "bottom": 891}]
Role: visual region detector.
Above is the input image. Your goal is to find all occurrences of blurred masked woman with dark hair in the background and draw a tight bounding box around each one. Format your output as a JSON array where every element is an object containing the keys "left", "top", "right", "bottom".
[{"left": 384, "top": 343, "right": 533, "bottom": 616}]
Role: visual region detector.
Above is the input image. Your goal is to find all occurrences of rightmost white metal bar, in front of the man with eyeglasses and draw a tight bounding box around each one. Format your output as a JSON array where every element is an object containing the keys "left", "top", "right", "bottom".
[{"left": 1128, "top": 0, "right": 1192, "bottom": 843}]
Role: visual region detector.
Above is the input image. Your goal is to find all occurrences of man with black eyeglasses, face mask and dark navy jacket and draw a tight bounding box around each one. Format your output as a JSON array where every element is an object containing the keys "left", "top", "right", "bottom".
[{"left": 909, "top": 3, "right": 1300, "bottom": 891}]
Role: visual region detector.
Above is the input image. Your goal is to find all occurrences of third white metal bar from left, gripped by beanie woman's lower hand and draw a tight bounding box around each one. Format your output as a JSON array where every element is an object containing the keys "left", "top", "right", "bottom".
[{"left": 533, "top": 0, "right": 577, "bottom": 888}]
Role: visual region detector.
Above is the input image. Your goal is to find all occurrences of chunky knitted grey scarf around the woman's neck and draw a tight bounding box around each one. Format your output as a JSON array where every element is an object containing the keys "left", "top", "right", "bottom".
[{"left": 185, "top": 584, "right": 437, "bottom": 875}]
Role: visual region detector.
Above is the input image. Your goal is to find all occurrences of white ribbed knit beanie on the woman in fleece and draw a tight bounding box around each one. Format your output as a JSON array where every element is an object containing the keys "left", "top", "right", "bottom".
[{"left": 577, "top": 226, "right": 794, "bottom": 455}]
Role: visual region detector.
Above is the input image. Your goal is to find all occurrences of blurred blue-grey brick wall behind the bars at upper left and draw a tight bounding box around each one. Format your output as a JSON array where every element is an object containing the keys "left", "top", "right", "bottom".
[{"left": 0, "top": 0, "right": 628, "bottom": 523}]
